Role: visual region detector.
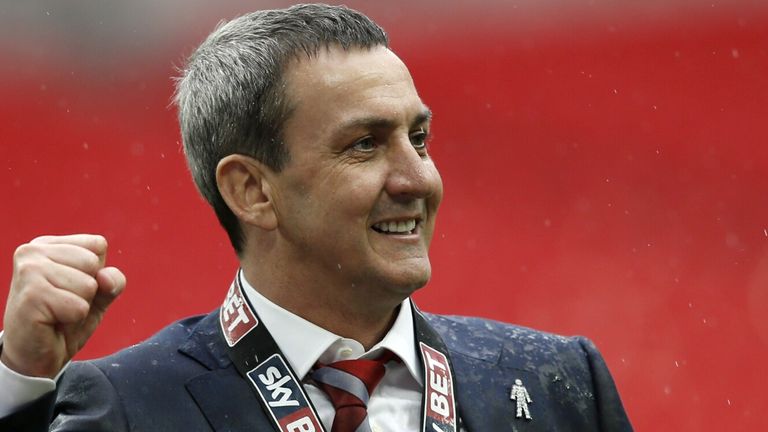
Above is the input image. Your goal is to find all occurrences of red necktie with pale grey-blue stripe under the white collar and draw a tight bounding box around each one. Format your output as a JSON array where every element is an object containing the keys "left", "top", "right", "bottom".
[{"left": 312, "top": 351, "right": 394, "bottom": 432}]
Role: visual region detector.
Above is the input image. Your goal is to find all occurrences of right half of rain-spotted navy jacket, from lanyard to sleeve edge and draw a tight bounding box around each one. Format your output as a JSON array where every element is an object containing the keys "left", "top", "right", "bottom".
[{"left": 424, "top": 314, "right": 632, "bottom": 432}]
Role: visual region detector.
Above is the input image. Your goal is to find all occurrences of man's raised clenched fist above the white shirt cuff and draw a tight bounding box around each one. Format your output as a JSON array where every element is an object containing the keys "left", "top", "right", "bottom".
[{"left": 0, "top": 234, "right": 125, "bottom": 378}]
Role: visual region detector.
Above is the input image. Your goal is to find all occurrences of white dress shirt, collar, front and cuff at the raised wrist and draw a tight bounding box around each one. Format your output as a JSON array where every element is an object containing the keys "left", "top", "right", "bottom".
[{"left": 0, "top": 278, "right": 423, "bottom": 432}]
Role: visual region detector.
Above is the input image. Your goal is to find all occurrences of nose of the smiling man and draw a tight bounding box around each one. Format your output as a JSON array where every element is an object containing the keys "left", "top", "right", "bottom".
[{"left": 386, "top": 136, "right": 440, "bottom": 198}]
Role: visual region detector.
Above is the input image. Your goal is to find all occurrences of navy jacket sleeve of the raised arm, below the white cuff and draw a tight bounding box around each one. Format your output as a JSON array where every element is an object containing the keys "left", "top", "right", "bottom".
[{"left": 0, "top": 362, "right": 129, "bottom": 432}]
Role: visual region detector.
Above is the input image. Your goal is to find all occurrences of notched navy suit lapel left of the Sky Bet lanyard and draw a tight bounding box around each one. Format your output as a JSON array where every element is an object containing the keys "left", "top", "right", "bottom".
[{"left": 179, "top": 310, "right": 273, "bottom": 431}]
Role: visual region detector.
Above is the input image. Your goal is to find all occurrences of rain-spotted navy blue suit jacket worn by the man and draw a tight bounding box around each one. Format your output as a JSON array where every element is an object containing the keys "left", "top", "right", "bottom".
[{"left": 0, "top": 311, "right": 632, "bottom": 432}]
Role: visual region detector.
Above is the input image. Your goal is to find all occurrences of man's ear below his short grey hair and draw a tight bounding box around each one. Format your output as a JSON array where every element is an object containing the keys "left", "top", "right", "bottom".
[{"left": 216, "top": 154, "right": 277, "bottom": 230}]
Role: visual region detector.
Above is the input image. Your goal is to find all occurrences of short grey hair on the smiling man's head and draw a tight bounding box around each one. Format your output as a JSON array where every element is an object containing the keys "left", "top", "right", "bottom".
[{"left": 175, "top": 4, "right": 389, "bottom": 254}]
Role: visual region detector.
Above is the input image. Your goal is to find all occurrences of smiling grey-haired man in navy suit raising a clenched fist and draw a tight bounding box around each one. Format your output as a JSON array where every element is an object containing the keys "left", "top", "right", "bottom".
[{"left": 0, "top": 5, "right": 631, "bottom": 432}]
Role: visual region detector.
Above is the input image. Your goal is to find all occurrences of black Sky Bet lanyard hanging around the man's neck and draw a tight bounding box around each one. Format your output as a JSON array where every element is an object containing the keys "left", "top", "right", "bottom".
[{"left": 219, "top": 272, "right": 458, "bottom": 432}]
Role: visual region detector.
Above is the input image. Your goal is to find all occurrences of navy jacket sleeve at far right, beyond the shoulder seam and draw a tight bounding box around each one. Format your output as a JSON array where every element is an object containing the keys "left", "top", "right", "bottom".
[{"left": 576, "top": 337, "right": 632, "bottom": 432}]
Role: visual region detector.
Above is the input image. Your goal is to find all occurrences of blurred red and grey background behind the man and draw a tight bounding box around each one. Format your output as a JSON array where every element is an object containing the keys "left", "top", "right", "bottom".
[{"left": 0, "top": 0, "right": 768, "bottom": 431}]
